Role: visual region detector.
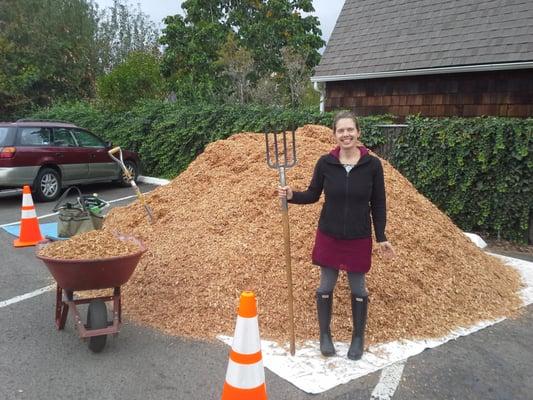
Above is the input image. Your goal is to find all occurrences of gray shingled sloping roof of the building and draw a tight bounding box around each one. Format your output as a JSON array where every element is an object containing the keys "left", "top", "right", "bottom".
[{"left": 313, "top": 0, "right": 533, "bottom": 80}]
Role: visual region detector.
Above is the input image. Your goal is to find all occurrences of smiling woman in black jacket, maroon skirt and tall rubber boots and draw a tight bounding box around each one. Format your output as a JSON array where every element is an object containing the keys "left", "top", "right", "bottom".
[{"left": 278, "top": 111, "right": 395, "bottom": 360}]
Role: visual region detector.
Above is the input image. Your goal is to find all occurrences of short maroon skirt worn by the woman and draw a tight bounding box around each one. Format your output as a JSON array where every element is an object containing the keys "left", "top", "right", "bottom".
[{"left": 312, "top": 229, "right": 372, "bottom": 273}]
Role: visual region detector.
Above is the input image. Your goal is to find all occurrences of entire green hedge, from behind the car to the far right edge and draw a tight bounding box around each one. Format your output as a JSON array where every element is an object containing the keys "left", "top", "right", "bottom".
[{"left": 33, "top": 101, "right": 533, "bottom": 242}]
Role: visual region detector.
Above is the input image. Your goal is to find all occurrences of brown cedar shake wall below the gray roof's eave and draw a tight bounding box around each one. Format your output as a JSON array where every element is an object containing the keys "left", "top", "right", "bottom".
[{"left": 325, "top": 69, "right": 533, "bottom": 118}]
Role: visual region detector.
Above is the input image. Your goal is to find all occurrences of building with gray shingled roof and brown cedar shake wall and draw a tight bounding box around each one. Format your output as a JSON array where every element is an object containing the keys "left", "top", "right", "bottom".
[{"left": 311, "top": 0, "right": 533, "bottom": 117}]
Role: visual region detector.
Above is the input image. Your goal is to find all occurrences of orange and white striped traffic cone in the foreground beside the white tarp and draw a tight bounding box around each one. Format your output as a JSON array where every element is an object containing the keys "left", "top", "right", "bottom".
[{"left": 222, "top": 292, "right": 267, "bottom": 400}]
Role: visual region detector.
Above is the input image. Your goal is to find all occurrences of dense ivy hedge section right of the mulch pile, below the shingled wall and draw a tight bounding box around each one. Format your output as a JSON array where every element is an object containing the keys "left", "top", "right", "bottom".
[{"left": 392, "top": 117, "right": 533, "bottom": 242}]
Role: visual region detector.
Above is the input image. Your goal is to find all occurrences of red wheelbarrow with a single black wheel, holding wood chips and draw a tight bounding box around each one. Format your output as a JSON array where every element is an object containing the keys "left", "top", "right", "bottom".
[{"left": 36, "top": 236, "right": 146, "bottom": 353}]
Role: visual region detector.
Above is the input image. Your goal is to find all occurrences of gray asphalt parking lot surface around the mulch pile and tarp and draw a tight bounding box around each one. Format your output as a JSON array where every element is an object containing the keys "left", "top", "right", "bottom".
[{"left": 0, "top": 184, "right": 533, "bottom": 400}]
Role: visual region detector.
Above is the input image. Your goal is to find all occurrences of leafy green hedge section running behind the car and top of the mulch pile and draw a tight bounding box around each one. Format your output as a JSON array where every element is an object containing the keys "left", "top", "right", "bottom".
[{"left": 32, "top": 101, "right": 391, "bottom": 178}]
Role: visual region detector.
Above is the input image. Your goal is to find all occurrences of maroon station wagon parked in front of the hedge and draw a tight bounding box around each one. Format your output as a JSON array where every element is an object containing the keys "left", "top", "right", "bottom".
[{"left": 0, "top": 120, "right": 140, "bottom": 201}]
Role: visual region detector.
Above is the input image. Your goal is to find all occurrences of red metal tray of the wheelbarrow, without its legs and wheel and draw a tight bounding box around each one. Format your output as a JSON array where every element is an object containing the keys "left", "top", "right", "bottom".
[{"left": 37, "top": 236, "right": 146, "bottom": 291}]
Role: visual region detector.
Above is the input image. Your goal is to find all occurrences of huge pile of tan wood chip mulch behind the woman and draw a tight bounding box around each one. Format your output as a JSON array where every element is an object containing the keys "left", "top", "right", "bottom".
[{"left": 83, "top": 126, "right": 521, "bottom": 343}]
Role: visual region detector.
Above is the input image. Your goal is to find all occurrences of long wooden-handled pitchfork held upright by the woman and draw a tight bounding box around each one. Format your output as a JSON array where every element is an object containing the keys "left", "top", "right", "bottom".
[{"left": 265, "top": 129, "right": 296, "bottom": 356}]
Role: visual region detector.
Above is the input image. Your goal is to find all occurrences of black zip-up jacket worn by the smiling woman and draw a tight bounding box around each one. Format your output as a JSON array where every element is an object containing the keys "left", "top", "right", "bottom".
[{"left": 289, "top": 151, "right": 387, "bottom": 242}]
